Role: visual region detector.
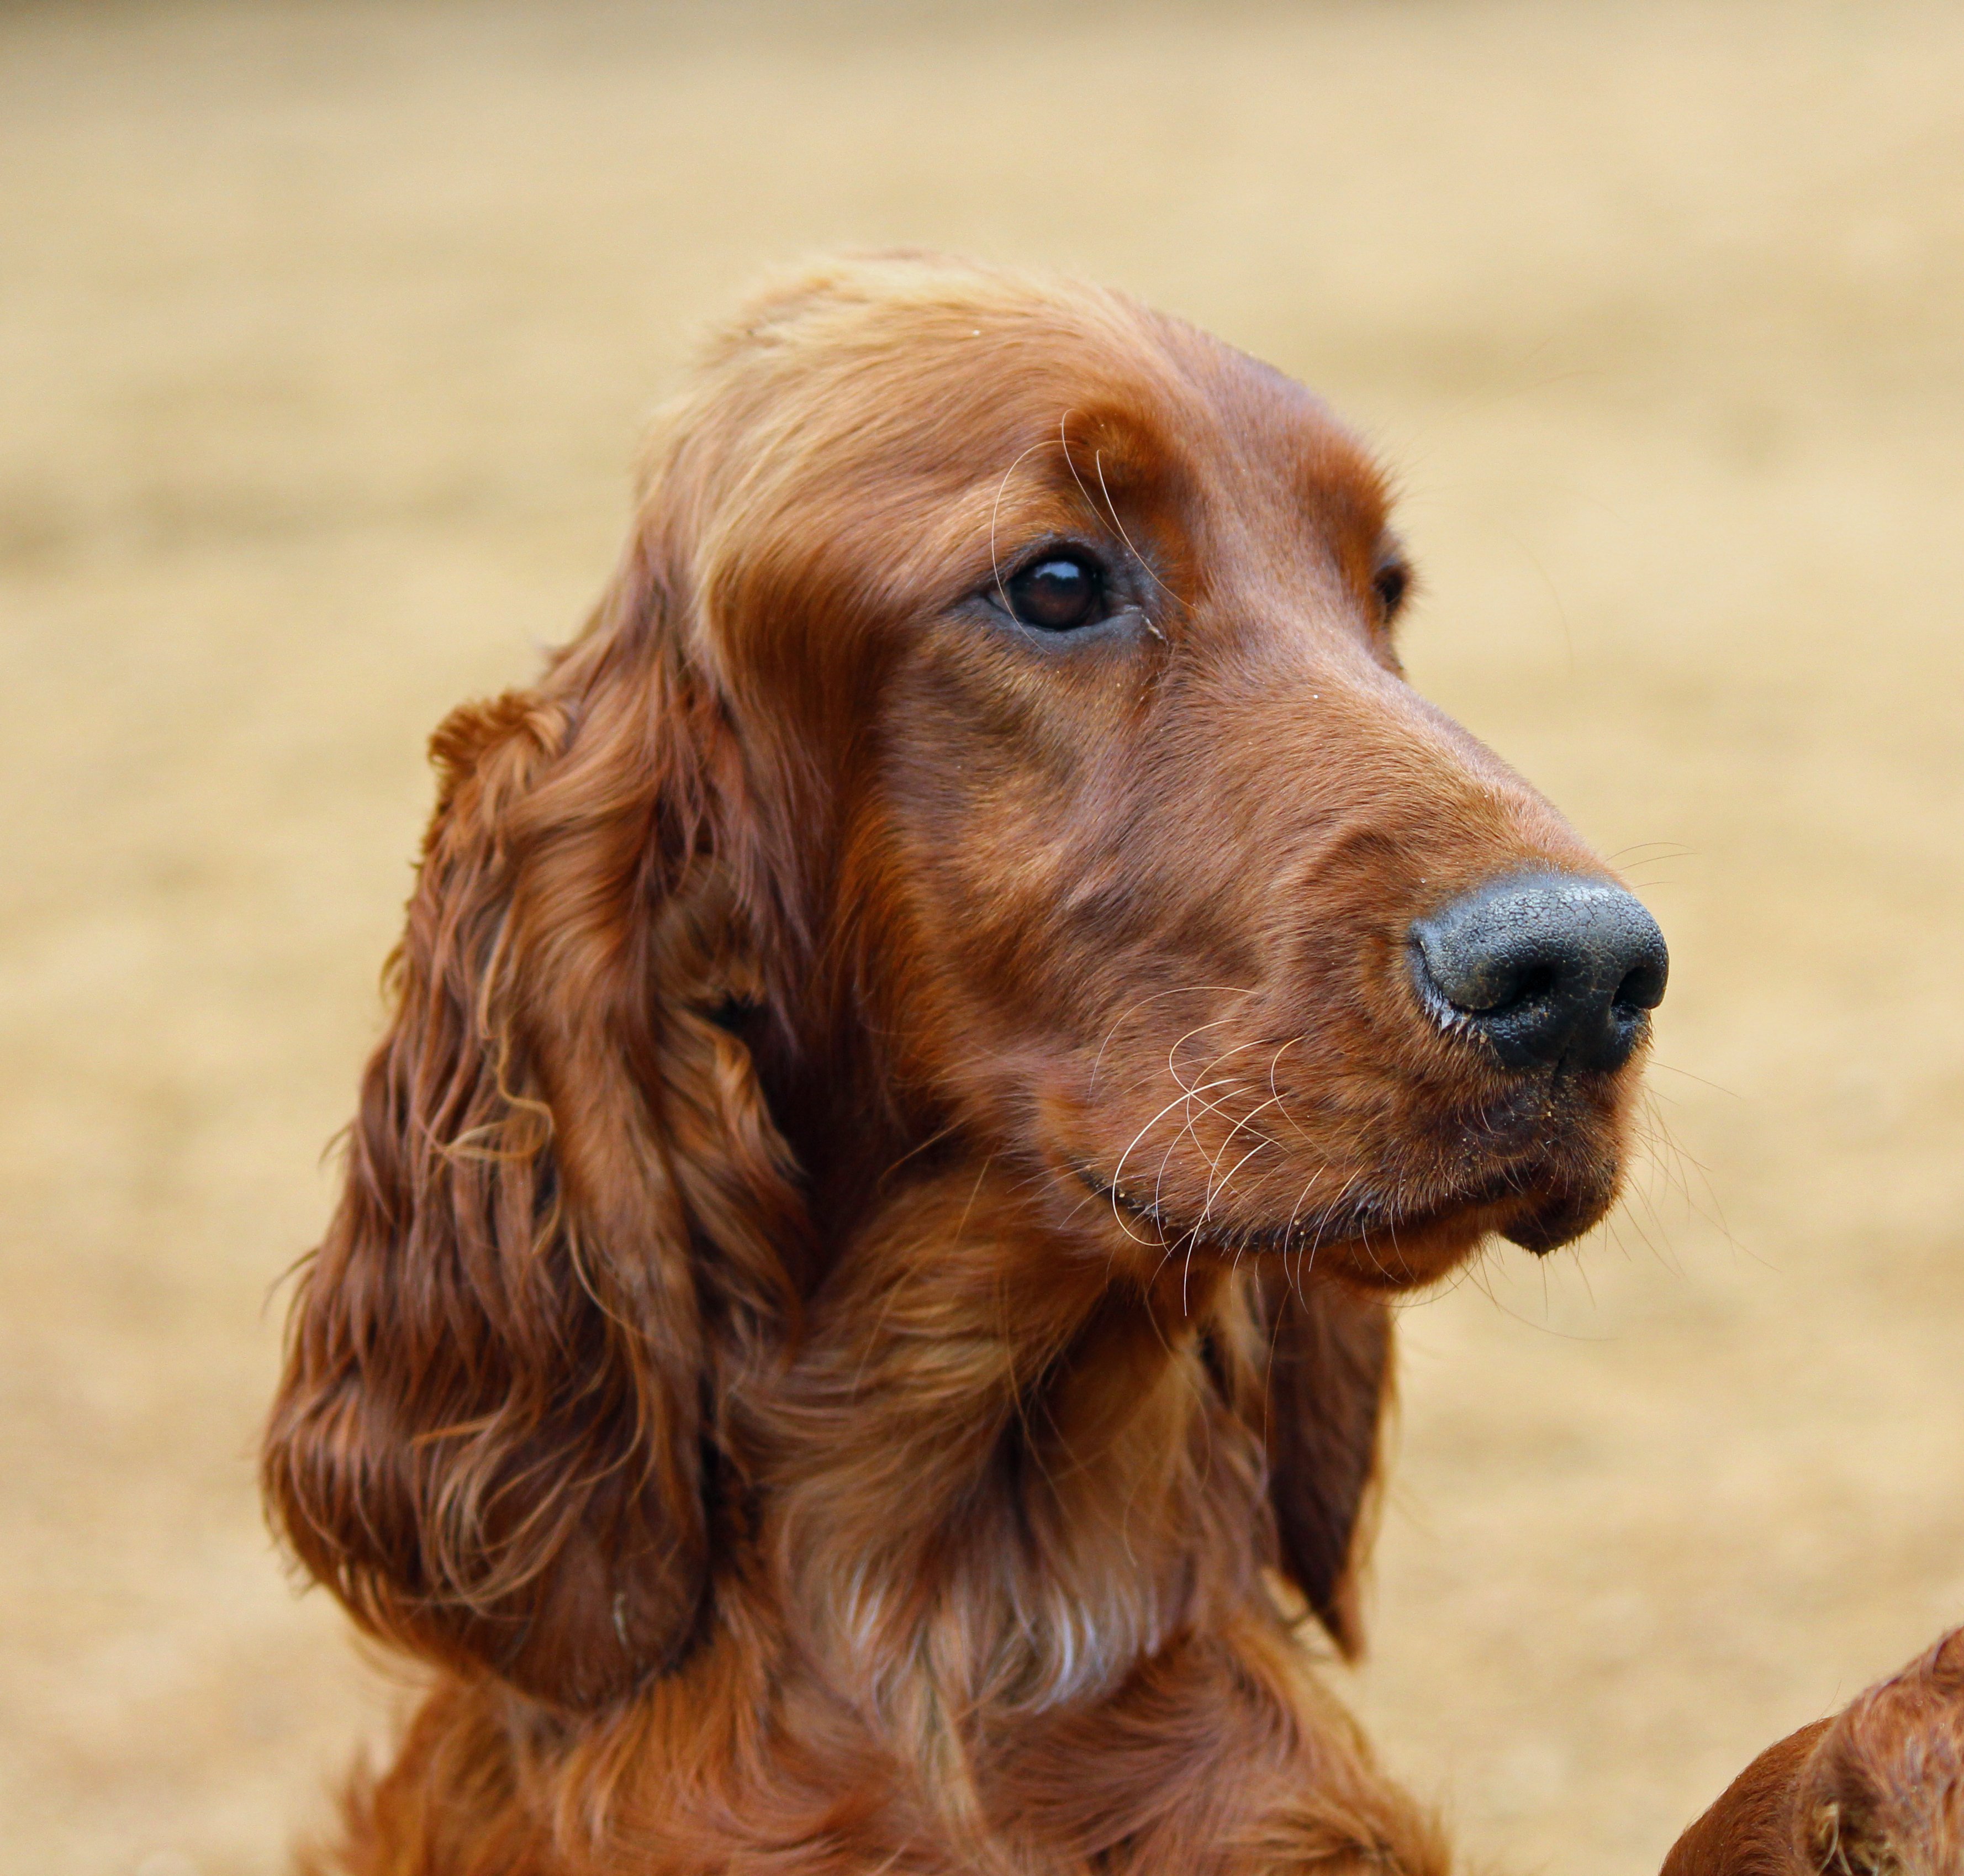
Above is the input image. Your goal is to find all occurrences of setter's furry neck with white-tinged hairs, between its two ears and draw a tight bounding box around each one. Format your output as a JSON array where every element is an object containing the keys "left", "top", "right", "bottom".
[{"left": 768, "top": 1165, "right": 1261, "bottom": 1723}]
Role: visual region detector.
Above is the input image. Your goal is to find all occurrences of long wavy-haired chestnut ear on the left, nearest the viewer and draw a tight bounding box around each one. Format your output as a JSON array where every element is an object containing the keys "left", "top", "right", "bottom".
[{"left": 263, "top": 556, "right": 805, "bottom": 1707}]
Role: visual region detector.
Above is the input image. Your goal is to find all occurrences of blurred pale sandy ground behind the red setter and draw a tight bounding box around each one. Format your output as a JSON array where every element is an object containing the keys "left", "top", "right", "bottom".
[{"left": 0, "top": 0, "right": 1964, "bottom": 1876}]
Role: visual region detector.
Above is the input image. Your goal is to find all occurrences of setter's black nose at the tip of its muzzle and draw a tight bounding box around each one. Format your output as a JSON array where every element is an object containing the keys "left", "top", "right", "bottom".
[{"left": 1412, "top": 874, "right": 1671, "bottom": 1071}]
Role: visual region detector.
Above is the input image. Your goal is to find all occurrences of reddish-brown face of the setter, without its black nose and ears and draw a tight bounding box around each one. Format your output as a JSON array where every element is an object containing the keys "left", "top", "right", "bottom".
[{"left": 675, "top": 261, "right": 1661, "bottom": 1285}]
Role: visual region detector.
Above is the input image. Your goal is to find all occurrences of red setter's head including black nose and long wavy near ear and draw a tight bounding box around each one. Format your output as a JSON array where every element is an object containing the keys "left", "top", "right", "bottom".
[{"left": 267, "top": 257, "right": 1664, "bottom": 1705}]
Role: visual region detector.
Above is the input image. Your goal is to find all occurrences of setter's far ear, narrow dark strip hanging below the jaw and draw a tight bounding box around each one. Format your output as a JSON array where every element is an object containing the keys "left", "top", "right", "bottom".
[{"left": 1259, "top": 1259, "right": 1391, "bottom": 1656}]
